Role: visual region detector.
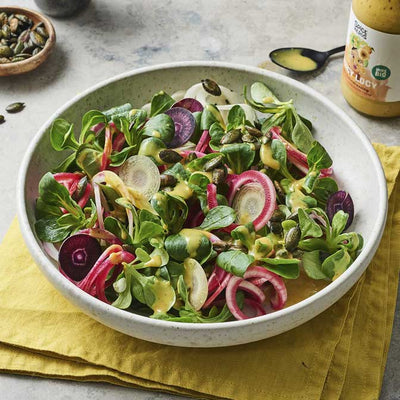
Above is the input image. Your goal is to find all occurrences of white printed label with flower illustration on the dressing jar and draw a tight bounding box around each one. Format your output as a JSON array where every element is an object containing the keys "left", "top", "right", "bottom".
[{"left": 343, "top": 9, "right": 400, "bottom": 102}]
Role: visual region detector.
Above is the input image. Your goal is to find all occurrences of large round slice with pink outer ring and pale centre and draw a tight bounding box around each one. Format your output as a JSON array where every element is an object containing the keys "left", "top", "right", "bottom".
[{"left": 228, "top": 170, "right": 276, "bottom": 231}]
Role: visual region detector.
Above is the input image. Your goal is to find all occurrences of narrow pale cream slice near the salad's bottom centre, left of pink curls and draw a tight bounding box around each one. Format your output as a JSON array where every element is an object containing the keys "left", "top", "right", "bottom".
[{"left": 183, "top": 258, "right": 208, "bottom": 310}]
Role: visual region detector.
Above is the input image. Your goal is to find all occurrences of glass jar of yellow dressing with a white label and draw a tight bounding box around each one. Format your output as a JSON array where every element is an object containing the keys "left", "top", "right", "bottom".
[{"left": 341, "top": 0, "right": 400, "bottom": 117}]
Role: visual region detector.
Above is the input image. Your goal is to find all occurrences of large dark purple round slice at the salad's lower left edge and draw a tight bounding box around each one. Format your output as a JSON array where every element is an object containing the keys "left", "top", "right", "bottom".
[{"left": 58, "top": 233, "right": 102, "bottom": 281}]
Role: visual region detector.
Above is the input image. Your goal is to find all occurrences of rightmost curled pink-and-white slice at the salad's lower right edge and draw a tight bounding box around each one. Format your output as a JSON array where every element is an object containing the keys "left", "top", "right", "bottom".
[{"left": 244, "top": 265, "right": 287, "bottom": 310}]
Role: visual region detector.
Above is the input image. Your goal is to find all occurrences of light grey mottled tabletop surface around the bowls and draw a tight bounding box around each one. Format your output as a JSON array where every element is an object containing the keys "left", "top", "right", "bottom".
[{"left": 0, "top": 0, "right": 400, "bottom": 400}]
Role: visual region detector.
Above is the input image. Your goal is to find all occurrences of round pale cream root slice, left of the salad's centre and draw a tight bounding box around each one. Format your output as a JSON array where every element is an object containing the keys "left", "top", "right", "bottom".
[{"left": 119, "top": 155, "right": 160, "bottom": 200}]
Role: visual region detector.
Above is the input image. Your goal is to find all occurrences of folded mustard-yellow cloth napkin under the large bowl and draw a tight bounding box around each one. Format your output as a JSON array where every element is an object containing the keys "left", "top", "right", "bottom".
[{"left": 0, "top": 145, "right": 400, "bottom": 400}]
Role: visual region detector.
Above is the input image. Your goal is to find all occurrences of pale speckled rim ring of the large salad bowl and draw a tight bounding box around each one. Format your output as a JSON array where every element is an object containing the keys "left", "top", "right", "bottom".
[{"left": 17, "top": 61, "right": 387, "bottom": 336}]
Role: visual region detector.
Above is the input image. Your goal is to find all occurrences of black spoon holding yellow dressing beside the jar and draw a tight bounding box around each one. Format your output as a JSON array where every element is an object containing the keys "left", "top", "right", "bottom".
[{"left": 269, "top": 46, "right": 346, "bottom": 72}]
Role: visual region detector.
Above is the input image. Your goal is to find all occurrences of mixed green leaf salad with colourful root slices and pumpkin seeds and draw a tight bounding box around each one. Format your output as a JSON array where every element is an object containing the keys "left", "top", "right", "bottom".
[{"left": 35, "top": 79, "right": 363, "bottom": 323}]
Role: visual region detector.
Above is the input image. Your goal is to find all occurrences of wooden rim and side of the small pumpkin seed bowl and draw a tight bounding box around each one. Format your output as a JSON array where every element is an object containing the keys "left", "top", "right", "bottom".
[{"left": 0, "top": 7, "right": 56, "bottom": 76}]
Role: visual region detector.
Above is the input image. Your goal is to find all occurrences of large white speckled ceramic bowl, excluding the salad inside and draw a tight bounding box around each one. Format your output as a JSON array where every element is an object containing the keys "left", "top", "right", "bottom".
[{"left": 18, "top": 62, "right": 387, "bottom": 347}]
